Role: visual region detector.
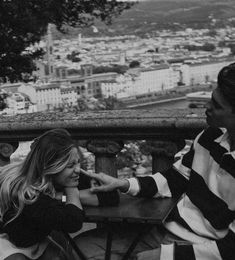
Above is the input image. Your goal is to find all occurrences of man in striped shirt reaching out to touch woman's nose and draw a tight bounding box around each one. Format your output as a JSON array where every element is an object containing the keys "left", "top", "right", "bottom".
[{"left": 78, "top": 63, "right": 235, "bottom": 260}]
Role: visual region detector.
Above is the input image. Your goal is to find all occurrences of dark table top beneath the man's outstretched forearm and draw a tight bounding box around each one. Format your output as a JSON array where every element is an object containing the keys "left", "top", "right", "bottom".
[{"left": 84, "top": 194, "right": 178, "bottom": 224}]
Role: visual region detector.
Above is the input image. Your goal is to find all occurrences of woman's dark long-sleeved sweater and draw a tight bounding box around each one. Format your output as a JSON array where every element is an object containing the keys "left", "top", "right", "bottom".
[{"left": 2, "top": 195, "right": 84, "bottom": 247}]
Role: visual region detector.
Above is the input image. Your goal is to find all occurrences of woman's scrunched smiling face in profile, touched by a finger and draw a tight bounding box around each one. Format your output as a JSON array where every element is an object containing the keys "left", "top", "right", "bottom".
[{"left": 53, "top": 147, "right": 80, "bottom": 187}]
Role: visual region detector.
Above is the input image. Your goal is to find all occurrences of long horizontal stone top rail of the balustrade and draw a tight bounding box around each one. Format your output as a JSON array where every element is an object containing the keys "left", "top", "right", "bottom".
[{"left": 0, "top": 109, "right": 206, "bottom": 141}]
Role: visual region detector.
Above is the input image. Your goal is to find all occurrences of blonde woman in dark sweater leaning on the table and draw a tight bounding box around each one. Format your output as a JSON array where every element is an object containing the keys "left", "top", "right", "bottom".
[{"left": 0, "top": 129, "right": 102, "bottom": 260}]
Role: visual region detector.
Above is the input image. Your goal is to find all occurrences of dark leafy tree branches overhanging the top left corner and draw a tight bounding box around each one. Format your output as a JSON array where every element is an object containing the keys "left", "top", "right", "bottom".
[{"left": 0, "top": 0, "right": 133, "bottom": 82}]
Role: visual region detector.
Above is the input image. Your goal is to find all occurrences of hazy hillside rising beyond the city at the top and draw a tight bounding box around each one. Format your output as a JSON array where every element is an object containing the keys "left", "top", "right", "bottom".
[{"left": 52, "top": 0, "right": 235, "bottom": 37}]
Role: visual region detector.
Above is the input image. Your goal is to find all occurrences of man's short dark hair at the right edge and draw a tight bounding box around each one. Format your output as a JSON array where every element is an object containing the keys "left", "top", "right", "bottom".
[{"left": 217, "top": 63, "right": 235, "bottom": 108}]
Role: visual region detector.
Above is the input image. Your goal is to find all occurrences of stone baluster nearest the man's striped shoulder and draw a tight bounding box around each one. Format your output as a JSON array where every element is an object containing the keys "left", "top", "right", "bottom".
[{"left": 141, "top": 140, "right": 185, "bottom": 173}]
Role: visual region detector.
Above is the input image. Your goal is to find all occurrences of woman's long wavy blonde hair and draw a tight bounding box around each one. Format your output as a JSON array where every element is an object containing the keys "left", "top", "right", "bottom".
[{"left": 0, "top": 129, "right": 76, "bottom": 224}]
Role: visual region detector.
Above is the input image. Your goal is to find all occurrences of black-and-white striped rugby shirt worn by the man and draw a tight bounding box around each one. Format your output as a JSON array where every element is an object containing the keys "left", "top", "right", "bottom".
[{"left": 127, "top": 127, "right": 235, "bottom": 260}]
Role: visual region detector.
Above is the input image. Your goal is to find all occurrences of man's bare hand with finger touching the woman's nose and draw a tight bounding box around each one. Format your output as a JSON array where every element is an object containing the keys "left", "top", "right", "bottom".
[{"left": 80, "top": 169, "right": 130, "bottom": 192}]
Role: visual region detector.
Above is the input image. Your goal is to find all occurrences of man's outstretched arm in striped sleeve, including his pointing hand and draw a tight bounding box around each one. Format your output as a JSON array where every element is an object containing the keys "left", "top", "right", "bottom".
[{"left": 81, "top": 137, "right": 196, "bottom": 197}]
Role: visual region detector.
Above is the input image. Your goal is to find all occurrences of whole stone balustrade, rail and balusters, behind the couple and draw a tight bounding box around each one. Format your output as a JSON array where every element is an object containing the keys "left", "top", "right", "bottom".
[{"left": 0, "top": 109, "right": 206, "bottom": 176}]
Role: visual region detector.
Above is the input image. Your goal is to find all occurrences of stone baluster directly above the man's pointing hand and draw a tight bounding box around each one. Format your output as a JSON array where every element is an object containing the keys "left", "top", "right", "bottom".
[{"left": 86, "top": 140, "right": 124, "bottom": 177}]
